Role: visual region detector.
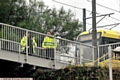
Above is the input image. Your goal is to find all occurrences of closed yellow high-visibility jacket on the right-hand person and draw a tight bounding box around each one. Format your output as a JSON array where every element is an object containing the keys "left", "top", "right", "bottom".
[{"left": 42, "top": 36, "right": 57, "bottom": 48}]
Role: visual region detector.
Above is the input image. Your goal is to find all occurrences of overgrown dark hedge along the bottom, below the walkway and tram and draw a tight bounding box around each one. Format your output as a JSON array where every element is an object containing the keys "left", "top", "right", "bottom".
[{"left": 32, "top": 66, "right": 120, "bottom": 80}]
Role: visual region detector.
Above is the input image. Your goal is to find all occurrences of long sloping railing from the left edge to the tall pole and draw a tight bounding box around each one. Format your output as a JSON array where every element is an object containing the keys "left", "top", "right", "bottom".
[{"left": 0, "top": 23, "right": 95, "bottom": 64}]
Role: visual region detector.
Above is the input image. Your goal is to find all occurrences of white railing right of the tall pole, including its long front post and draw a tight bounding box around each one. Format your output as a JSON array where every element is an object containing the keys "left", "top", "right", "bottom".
[{"left": 96, "top": 43, "right": 120, "bottom": 80}]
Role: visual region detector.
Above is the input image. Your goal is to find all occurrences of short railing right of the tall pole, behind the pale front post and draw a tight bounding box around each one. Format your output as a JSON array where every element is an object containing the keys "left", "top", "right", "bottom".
[{"left": 96, "top": 43, "right": 120, "bottom": 67}]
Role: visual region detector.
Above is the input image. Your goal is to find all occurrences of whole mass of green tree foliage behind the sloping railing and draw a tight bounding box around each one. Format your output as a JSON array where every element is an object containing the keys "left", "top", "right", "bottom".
[{"left": 0, "top": 0, "right": 82, "bottom": 40}]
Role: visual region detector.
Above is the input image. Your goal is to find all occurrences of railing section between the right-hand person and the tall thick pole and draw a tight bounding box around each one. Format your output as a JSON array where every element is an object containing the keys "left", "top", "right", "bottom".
[{"left": 56, "top": 38, "right": 94, "bottom": 64}]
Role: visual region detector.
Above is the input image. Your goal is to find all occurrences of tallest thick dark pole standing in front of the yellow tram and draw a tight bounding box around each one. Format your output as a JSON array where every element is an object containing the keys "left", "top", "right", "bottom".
[{"left": 92, "top": 0, "right": 98, "bottom": 65}]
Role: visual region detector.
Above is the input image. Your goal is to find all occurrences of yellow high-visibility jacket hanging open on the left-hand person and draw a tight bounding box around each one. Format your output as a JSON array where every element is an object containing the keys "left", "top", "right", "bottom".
[{"left": 20, "top": 36, "right": 37, "bottom": 53}]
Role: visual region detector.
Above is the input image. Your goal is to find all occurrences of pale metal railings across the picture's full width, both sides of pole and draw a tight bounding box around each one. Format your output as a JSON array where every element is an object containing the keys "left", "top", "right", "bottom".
[{"left": 0, "top": 23, "right": 120, "bottom": 80}]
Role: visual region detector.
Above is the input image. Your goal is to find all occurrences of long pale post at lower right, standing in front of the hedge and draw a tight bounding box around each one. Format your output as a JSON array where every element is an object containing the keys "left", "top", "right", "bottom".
[{"left": 108, "top": 45, "right": 113, "bottom": 80}]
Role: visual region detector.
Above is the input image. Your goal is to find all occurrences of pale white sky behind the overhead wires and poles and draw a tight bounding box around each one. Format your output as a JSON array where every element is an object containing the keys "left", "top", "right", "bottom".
[{"left": 42, "top": 0, "right": 120, "bottom": 32}]
